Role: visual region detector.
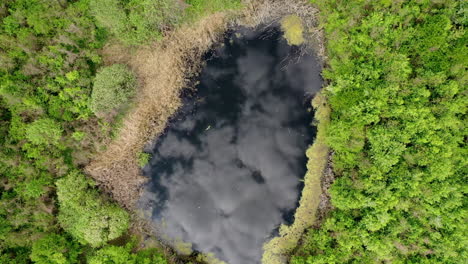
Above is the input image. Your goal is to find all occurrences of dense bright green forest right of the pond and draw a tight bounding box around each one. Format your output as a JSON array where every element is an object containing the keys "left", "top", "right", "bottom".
[{"left": 292, "top": 0, "right": 468, "bottom": 264}]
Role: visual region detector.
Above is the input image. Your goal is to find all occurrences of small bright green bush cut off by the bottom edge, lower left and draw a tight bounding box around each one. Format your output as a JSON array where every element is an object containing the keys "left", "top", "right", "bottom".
[{"left": 31, "top": 234, "right": 80, "bottom": 264}]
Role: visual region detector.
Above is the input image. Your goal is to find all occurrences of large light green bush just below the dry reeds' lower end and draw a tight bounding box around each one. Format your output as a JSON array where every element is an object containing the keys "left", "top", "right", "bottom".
[{"left": 56, "top": 172, "right": 129, "bottom": 247}]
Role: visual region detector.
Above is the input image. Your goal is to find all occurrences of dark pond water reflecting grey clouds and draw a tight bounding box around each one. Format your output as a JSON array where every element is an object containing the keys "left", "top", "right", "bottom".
[{"left": 140, "top": 26, "right": 322, "bottom": 264}]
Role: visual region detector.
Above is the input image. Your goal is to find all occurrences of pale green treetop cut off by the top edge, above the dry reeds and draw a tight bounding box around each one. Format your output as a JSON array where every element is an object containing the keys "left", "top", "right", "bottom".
[{"left": 90, "top": 0, "right": 181, "bottom": 44}]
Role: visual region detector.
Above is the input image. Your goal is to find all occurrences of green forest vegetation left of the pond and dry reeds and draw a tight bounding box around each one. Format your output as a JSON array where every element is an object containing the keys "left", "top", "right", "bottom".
[{"left": 0, "top": 0, "right": 239, "bottom": 264}]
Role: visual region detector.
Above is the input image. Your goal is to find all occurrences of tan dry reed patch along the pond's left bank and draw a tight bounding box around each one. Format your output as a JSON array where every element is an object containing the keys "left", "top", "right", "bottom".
[{"left": 85, "top": 13, "right": 232, "bottom": 209}]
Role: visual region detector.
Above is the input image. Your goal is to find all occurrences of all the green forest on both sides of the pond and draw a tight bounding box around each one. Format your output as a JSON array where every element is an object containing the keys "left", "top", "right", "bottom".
[{"left": 0, "top": 0, "right": 468, "bottom": 264}]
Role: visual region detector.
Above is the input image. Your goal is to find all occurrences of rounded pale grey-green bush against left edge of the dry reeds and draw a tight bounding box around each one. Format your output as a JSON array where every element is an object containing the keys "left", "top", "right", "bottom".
[{"left": 90, "top": 64, "right": 136, "bottom": 115}]
